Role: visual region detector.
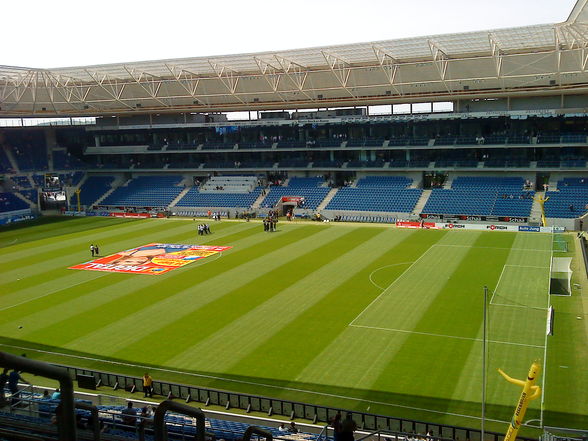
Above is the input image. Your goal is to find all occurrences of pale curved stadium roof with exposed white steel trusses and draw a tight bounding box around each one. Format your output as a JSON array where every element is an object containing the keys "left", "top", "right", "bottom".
[{"left": 0, "top": 0, "right": 588, "bottom": 117}]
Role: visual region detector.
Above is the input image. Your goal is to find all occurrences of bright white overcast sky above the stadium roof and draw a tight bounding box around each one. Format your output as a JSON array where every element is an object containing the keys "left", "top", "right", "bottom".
[{"left": 0, "top": 0, "right": 576, "bottom": 68}]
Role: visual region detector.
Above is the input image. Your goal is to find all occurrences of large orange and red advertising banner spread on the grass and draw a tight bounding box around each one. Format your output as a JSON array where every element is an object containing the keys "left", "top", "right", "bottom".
[{"left": 69, "top": 243, "right": 232, "bottom": 275}]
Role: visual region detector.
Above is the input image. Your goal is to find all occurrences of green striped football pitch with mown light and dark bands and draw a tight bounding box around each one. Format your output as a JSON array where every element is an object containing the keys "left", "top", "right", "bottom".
[{"left": 0, "top": 218, "right": 588, "bottom": 428}]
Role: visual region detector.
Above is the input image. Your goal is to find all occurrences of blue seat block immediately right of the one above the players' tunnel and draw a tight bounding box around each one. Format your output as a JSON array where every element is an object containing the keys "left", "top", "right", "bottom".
[{"left": 326, "top": 176, "right": 423, "bottom": 213}]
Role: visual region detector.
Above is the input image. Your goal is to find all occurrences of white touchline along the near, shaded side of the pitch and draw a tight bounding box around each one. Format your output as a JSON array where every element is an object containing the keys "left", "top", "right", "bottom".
[{"left": 0, "top": 343, "right": 520, "bottom": 423}]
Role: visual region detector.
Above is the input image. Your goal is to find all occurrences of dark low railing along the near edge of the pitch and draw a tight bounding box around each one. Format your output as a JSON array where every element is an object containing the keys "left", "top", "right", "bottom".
[{"left": 59, "top": 365, "right": 536, "bottom": 441}]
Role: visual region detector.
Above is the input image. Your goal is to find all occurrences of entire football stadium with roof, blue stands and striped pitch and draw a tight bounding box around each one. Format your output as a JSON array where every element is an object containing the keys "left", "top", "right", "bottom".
[{"left": 0, "top": 0, "right": 588, "bottom": 441}]
